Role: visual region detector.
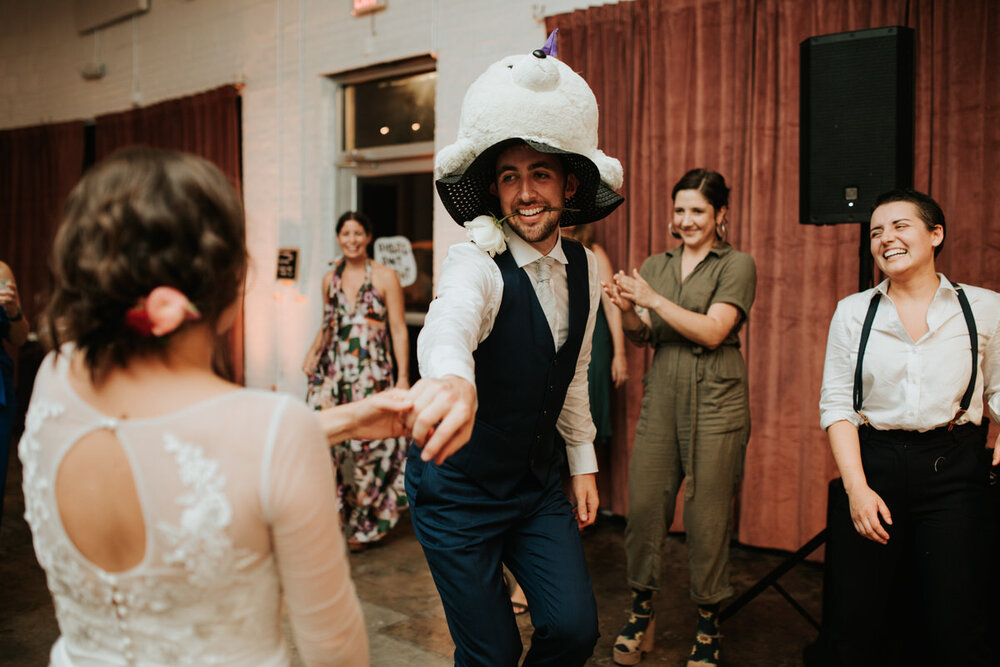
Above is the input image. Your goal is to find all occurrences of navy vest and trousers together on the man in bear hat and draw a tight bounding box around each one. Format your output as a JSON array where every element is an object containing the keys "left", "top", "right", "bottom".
[{"left": 406, "top": 240, "right": 597, "bottom": 667}]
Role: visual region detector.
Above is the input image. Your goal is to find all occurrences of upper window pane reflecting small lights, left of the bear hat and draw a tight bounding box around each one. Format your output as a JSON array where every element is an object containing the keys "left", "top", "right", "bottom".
[{"left": 354, "top": 72, "right": 437, "bottom": 148}]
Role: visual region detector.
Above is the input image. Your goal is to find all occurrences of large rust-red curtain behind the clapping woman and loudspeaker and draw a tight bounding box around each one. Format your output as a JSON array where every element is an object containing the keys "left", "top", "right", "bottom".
[{"left": 546, "top": 0, "right": 1000, "bottom": 549}]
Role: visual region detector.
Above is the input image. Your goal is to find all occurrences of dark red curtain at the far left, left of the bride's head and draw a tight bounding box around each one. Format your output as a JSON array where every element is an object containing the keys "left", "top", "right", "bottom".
[{"left": 0, "top": 121, "right": 84, "bottom": 329}]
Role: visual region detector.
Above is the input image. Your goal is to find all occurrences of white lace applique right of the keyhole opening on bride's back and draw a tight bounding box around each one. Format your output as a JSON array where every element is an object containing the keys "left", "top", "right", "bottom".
[{"left": 159, "top": 434, "right": 252, "bottom": 586}]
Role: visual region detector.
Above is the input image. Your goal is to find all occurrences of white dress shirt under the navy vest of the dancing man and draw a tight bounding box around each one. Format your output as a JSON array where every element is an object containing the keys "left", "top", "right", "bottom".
[{"left": 417, "top": 224, "right": 601, "bottom": 475}]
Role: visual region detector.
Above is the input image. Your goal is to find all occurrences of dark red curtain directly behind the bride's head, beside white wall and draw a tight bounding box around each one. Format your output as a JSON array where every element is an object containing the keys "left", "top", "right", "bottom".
[{"left": 94, "top": 85, "right": 243, "bottom": 383}]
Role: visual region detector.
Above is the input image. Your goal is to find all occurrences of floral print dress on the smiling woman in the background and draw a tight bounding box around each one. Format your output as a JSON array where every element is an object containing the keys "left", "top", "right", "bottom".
[{"left": 306, "top": 261, "right": 407, "bottom": 543}]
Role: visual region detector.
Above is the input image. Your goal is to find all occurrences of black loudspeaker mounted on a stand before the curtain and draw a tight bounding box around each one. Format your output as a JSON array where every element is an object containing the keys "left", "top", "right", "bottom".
[{"left": 799, "top": 26, "right": 914, "bottom": 225}]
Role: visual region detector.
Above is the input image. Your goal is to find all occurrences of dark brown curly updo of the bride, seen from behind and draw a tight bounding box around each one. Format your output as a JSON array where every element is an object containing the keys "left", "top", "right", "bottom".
[{"left": 43, "top": 147, "right": 247, "bottom": 382}]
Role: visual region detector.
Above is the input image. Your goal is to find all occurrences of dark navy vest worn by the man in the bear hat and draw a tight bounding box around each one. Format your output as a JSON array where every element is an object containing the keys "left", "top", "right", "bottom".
[{"left": 445, "top": 237, "right": 590, "bottom": 498}]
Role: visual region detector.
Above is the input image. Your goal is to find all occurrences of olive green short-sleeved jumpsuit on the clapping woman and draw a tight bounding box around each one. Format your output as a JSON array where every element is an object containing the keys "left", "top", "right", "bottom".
[{"left": 625, "top": 243, "right": 757, "bottom": 604}]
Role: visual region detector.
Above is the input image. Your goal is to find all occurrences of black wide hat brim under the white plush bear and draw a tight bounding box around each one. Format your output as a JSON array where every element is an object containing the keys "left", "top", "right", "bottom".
[{"left": 436, "top": 138, "right": 625, "bottom": 227}]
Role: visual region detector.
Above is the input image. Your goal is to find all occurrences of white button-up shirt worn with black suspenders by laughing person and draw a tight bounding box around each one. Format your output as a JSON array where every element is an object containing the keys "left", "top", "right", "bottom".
[{"left": 820, "top": 274, "right": 1000, "bottom": 431}]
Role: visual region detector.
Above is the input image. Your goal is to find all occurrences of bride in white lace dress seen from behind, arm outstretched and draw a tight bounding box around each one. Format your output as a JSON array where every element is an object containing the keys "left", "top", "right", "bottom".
[{"left": 20, "top": 149, "right": 412, "bottom": 666}]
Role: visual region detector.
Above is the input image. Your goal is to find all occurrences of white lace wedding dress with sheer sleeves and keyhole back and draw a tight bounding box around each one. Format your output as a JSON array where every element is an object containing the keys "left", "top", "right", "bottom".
[{"left": 19, "top": 352, "right": 368, "bottom": 667}]
